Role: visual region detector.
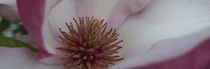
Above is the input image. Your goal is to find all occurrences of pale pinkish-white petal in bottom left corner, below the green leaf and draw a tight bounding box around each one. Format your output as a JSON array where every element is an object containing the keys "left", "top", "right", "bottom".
[{"left": 0, "top": 47, "right": 62, "bottom": 69}]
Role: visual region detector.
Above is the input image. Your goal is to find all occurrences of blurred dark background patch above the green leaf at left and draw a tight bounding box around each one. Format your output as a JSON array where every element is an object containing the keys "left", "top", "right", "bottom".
[{"left": 0, "top": 4, "right": 27, "bottom": 37}]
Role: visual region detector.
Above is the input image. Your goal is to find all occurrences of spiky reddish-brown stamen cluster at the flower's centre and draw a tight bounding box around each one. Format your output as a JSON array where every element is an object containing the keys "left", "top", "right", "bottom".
[{"left": 57, "top": 17, "right": 123, "bottom": 69}]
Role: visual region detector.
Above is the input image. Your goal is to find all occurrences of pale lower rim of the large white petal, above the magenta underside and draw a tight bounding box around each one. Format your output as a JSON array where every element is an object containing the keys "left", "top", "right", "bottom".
[{"left": 113, "top": 28, "right": 210, "bottom": 69}]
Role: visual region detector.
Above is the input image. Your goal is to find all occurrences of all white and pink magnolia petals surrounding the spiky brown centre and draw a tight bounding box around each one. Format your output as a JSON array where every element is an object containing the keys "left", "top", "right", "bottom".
[{"left": 0, "top": 0, "right": 210, "bottom": 69}]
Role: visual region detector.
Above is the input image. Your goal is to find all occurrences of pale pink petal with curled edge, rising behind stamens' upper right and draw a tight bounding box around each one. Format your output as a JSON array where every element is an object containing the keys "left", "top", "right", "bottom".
[{"left": 108, "top": 0, "right": 150, "bottom": 28}]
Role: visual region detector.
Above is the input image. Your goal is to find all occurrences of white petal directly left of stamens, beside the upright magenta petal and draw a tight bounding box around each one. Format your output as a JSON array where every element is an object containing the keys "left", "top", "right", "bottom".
[{"left": 42, "top": 0, "right": 76, "bottom": 54}]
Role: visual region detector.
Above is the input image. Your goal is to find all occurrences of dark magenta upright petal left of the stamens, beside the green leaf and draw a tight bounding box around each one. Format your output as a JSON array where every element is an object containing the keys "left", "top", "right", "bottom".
[{"left": 17, "top": 0, "right": 62, "bottom": 62}]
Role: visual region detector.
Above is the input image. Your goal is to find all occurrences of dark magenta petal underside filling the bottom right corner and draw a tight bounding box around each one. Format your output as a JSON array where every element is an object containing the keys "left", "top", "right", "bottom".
[{"left": 137, "top": 38, "right": 210, "bottom": 69}]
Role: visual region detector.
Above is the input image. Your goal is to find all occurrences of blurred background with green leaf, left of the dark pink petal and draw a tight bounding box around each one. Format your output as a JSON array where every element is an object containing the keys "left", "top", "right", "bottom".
[{"left": 0, "top": 4, "right": 38, "bottom": 52}]
